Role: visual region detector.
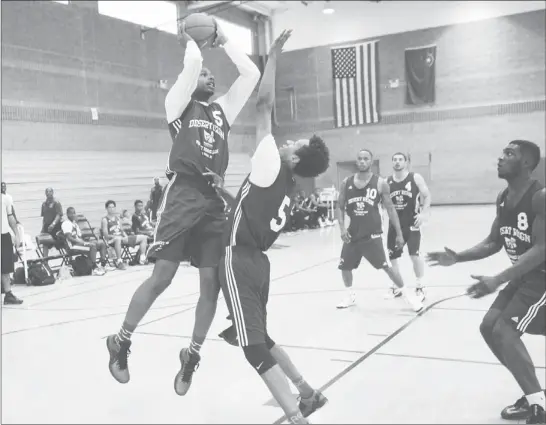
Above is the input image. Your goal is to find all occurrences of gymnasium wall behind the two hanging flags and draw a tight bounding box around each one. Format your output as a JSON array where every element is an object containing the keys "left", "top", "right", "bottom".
[{"left": 275, "top": 10, "right": 545, "bottom": 204}]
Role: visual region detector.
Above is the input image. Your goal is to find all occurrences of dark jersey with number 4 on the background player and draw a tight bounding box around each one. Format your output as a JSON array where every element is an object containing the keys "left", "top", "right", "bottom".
[{"left": 387, "top": 173, "right": 421, "bottom": 228}]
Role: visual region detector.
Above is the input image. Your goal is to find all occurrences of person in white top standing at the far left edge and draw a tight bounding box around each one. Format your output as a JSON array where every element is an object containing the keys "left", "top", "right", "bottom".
[{"left": 1, "top": 193, "right": 23, "bottom": 305}]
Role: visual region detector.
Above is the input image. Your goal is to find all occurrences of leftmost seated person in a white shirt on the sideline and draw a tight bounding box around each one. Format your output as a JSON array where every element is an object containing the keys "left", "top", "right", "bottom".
[{"left": 61, "top": 207, "right": 107, "bottom": 276}]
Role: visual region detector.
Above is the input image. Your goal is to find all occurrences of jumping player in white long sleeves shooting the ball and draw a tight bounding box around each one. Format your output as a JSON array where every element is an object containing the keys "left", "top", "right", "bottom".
[{"left": 107, "top": 19, "right": 260, "bottom": 395}]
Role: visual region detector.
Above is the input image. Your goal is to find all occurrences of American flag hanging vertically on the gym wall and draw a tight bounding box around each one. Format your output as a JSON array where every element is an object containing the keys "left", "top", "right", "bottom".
[{"left": 332, "top": 41, "right": 380, "bottom": 127}]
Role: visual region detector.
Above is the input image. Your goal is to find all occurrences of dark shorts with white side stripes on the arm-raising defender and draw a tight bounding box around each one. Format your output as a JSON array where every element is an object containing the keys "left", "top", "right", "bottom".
[{"left": 219, "top": 246, "right": 270, "bottom": 347}]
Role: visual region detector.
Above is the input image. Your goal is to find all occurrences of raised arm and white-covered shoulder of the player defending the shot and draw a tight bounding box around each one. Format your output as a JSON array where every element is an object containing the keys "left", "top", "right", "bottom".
[{"left": 249, "top": 31, "right": 291, "bottom": 187}]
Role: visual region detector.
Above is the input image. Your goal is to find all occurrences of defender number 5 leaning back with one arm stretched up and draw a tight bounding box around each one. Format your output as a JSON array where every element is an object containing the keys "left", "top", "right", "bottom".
[{"left": 216, "top": 31, "right": 329, "bottom": 423}]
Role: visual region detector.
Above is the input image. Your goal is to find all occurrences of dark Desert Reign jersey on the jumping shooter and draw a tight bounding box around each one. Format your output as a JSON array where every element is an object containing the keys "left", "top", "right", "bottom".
[{"left": 167, "top": 100, "right": 230, "bottom": 177}]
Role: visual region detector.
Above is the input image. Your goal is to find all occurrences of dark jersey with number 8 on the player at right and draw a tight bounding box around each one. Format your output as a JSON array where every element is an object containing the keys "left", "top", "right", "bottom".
[{"left": 497, "top": 180, "right": 545, "bottom": 271}]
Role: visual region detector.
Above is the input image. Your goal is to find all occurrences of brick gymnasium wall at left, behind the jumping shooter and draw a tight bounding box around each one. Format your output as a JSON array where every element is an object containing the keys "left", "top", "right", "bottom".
[{"left": 2, "top": 1, "right": 256, "bottom": 152}]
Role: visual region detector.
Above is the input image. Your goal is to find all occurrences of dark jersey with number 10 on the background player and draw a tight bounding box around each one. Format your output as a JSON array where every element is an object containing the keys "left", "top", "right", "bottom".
[{"left": 345, "top": 174, "right": 383, "bottom": 241}]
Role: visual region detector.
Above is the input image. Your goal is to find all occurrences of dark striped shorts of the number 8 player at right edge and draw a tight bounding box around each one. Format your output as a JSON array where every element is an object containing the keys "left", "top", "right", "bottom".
[{"left": 490, "top": 273, "right": 546, "bottom": 335}]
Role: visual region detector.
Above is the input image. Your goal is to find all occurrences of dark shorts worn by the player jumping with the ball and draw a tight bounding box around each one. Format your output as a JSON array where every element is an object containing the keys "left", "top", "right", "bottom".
[{"left": 148, "top": 174, "right": 226, "bottom": 268}]
